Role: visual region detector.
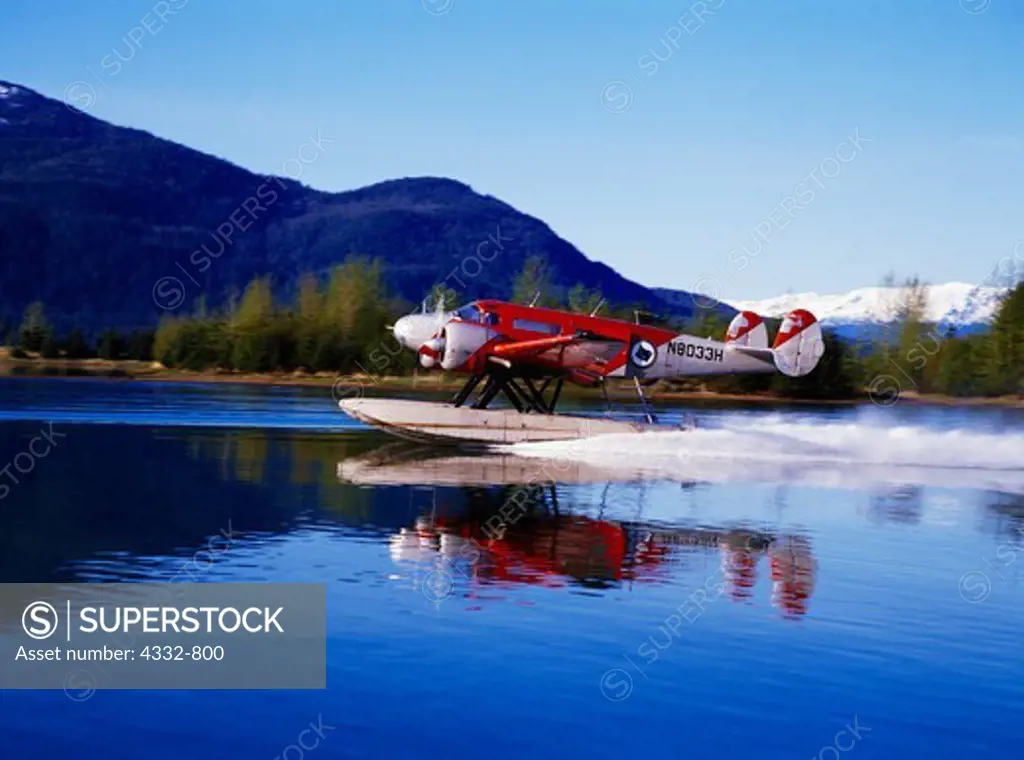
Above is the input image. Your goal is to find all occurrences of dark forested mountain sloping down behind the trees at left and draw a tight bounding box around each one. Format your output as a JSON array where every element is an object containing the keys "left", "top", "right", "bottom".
[{"left": 0, "top": 81, "right": 708, "bottom": 330}]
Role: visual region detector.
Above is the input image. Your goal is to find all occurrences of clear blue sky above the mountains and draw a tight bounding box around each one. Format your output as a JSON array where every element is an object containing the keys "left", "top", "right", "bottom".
[{"left": 0, "top": 0, "right": 1024, "bottom": 300}]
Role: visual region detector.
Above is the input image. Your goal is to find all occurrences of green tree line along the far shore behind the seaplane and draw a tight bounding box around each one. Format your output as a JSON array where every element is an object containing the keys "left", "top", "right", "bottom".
[{"left": 0, "top": 256, "right": 1024, "bottom": 400}]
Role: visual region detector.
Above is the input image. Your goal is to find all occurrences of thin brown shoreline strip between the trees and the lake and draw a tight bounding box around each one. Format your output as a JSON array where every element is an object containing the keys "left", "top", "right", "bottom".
[{"left": 0, "top": 356, "right": 1024, "bottom": 409}]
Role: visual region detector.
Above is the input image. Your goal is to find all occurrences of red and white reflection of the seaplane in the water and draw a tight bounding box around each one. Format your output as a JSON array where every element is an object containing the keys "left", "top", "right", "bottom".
[{"left": 338, "top": 444, "right": 817, "bottom": 616}]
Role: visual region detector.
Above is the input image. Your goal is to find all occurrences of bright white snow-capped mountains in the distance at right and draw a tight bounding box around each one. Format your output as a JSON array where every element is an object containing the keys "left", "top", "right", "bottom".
[{"left": 732, "top": 283, "right": 1007, "bottom": 333}]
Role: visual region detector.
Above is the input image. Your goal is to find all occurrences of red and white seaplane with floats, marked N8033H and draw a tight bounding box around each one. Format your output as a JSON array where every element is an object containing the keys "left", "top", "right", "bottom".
[{"left": 338, "top": 298, "right": 824, "bottom": 449}]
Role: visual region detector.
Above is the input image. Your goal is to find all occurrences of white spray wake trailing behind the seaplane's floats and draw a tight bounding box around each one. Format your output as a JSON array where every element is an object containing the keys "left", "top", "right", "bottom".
[{"left": 510, "top": 417, "right": 1024, "bottom": 491}]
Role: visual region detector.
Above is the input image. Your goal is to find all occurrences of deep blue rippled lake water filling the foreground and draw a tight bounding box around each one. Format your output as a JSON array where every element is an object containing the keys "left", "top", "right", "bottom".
[{"left": 0, "top": 379, "right": 1024, "bottom": 760}]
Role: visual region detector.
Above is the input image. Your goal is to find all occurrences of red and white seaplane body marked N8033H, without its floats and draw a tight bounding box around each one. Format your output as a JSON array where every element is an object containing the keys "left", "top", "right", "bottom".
[{"left": 394, "top": 299, "right": 823, "bottom": 385}]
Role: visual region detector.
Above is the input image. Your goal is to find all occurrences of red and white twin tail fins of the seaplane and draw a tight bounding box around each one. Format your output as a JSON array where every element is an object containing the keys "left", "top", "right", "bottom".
[{"left": 725, "top": 308, "right": 824, "bottom": 377}]
